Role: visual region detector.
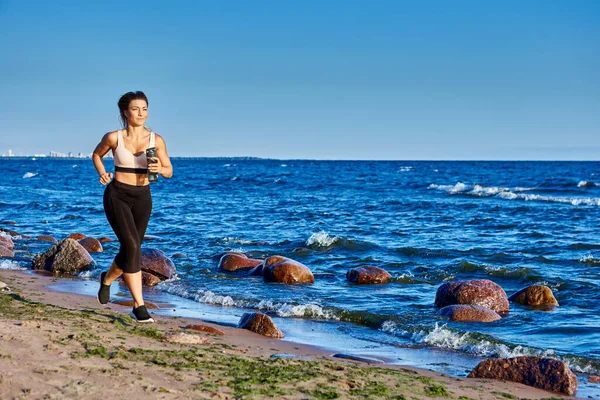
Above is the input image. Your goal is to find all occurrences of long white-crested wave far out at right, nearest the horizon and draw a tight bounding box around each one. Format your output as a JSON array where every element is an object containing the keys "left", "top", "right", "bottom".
[{"left": 427, "top": 182, "right": 600, "bottom": 206}]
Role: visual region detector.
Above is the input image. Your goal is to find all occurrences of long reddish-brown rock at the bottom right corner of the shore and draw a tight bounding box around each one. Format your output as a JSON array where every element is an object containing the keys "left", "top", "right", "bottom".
[{"left": 469, "top": 356, "right": 577, "bottom": 396}]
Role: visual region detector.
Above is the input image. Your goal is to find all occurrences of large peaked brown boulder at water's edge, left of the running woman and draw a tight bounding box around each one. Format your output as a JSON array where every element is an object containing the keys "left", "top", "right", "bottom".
[{"left": 31, "top": 238, "right": 94, "bottom": 274}]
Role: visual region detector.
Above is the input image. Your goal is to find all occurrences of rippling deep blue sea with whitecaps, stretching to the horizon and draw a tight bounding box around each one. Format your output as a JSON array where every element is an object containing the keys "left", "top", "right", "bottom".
[{"left": 0, "top": 157, "right": 600, "bottom": 398}]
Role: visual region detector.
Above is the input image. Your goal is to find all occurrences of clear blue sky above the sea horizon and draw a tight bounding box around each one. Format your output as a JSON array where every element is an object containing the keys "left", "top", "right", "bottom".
[{"left": 0, "top": 0, "right": 600, "bottom": 160}]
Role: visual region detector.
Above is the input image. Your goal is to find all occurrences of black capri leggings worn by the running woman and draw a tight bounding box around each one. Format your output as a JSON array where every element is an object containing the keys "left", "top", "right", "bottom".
[{"left": 104, "top": 179, "right": 152, "bottom": 274}]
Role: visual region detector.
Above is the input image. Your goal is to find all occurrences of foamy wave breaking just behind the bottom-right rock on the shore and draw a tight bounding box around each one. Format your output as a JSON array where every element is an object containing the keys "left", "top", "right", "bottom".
[{"left": 381, "top": 320, "right": 600, "bottom": 374}]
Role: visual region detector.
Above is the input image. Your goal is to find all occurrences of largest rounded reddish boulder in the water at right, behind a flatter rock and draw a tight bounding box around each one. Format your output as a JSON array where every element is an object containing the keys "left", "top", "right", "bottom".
[{"left": 435, "top": 279, "right": 509, "bottom": 314}]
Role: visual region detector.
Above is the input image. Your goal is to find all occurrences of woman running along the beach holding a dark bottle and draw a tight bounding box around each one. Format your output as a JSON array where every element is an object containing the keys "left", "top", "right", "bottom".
[{"left": 92, "top": 92, "right": 173, "bottom": 322}]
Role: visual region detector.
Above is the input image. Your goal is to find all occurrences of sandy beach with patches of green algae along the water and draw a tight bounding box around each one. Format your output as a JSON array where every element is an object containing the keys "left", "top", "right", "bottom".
[{"left": 0, "top": 270, "right": 568, "bottom": 399}]
